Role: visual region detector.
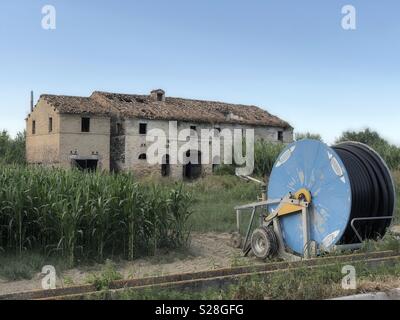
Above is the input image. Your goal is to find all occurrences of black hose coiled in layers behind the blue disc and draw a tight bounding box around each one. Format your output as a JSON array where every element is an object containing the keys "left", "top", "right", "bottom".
[{"left": 333, "top": 142, "right": 395, "bottom": 244}]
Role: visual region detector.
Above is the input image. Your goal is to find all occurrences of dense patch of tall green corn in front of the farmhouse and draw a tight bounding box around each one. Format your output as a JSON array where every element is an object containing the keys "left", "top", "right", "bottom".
[{"left": 0, "top": 166, "right": 191, "bottom": 265}]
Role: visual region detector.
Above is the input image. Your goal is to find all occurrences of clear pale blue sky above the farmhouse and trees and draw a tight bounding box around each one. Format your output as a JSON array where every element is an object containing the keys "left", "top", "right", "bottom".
[{"left": 0, "top": 0, "right": 400, "bottom": 144}]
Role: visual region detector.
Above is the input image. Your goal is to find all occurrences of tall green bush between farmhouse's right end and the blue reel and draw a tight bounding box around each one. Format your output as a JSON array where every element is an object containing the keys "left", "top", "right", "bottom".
[{"left": 254, "top": 140, "right": 285, "bottom": 177}]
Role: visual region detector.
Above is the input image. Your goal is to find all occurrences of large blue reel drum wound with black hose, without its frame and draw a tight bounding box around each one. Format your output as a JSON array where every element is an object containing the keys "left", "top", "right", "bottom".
[{"left": 267, "top": 140, "right": 395, "bottom": 255}]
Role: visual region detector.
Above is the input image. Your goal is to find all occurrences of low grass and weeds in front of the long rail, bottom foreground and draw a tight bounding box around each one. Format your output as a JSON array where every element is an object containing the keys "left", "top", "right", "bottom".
[{"left": 107, "top": 262, "right": 400, "bottom": 300}]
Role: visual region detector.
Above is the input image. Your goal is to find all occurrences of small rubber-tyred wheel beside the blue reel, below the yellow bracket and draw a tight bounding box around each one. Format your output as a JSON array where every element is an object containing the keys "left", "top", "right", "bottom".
[{"left": 251, "top": 228, "right": 278, "bottom": 260}]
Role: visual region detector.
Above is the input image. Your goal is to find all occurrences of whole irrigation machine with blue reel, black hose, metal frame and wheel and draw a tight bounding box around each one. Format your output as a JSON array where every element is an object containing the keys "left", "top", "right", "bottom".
[{"left": 232, "top": 140, "right": 395, "bottom": 261}]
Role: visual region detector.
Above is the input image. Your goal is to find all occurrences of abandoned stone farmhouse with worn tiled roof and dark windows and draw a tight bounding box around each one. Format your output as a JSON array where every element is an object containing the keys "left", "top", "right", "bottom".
[{"left": 26, "top": 89, "right": 293, "bottom": 179}]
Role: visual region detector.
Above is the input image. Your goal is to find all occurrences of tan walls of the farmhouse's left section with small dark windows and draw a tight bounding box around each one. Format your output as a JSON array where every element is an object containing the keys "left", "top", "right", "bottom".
[{"left": 26, "top": 100, "right": 110, "bottom": 171}]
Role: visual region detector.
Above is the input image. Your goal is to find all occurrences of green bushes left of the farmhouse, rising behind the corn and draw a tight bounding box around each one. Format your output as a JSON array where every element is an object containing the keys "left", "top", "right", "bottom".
[{"left": 0, "top": 130, "right": 25, "bottom": 165}]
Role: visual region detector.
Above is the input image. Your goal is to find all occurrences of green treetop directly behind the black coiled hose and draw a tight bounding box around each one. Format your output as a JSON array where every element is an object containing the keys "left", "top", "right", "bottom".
[{"left": 336, "top": 129, "right": 400, "bottom": 170}]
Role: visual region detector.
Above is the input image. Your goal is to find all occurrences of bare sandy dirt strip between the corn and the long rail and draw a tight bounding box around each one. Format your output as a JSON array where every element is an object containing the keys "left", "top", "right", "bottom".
[{"left": 0, "top": 233, "right": 256, "bottom": 295}]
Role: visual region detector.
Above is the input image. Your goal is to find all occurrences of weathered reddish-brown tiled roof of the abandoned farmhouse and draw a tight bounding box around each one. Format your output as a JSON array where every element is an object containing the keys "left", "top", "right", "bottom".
[{"left": 41, "top": 91, "right": 291, "bottom": 128}]
